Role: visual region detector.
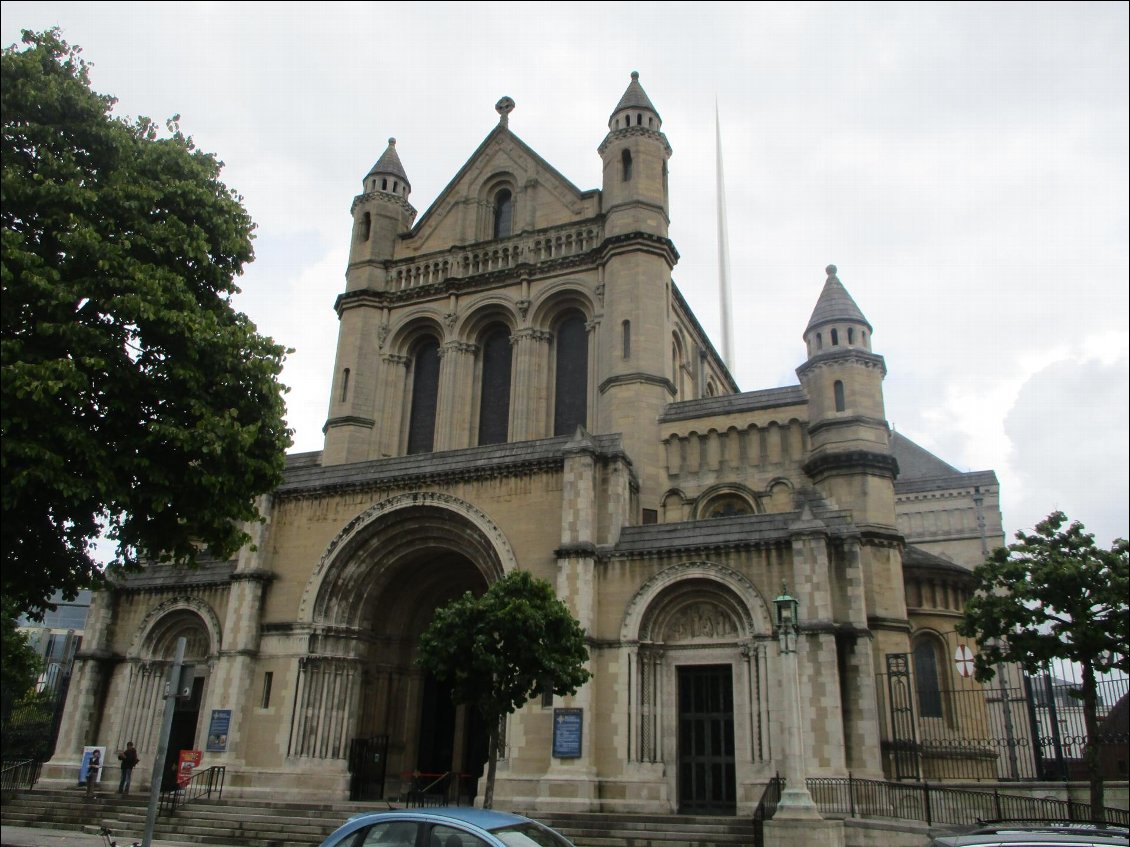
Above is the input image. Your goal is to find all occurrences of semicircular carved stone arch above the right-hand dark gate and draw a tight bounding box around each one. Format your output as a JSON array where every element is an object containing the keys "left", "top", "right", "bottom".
[{"left": 620, "top": 561, "right": 773, "bottom": 641}]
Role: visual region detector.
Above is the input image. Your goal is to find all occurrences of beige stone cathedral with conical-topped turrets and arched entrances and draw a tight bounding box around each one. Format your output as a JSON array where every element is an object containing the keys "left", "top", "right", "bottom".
[{"left": 44, "top": 73, "right": 1003, "bottom": 814}]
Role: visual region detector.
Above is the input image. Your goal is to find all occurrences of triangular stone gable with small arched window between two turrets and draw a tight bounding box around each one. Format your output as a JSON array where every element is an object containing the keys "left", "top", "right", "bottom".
[{"left": 405, "top": 124, "right": 599, "bottom": 253}]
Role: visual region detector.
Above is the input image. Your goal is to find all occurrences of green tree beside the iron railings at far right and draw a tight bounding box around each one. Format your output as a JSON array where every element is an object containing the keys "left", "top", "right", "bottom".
[{"left": 957, "top": 512, "right": 1130, "bottom": 815}]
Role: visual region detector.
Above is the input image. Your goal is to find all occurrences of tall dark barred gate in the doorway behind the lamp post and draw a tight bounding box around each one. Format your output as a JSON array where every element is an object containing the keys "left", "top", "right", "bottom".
[{"left": 678, "top": 665, "right": 737, "bottom": 814}]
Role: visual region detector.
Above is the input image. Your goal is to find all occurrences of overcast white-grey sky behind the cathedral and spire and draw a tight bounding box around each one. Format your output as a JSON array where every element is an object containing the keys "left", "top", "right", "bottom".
[{"left": 2, "top": 2, "right": 1130, "bottom": 544}]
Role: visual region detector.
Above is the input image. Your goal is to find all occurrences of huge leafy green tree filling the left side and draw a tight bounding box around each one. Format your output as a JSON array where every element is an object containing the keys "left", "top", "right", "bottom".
[{"left": 0, "top": 29, "right": 290, "bottom": 615}]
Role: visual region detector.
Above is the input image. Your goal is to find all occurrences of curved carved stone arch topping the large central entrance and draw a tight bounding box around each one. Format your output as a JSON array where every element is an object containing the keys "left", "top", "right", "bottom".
[{"left": 298, "top": 491, "right": 518, "bottom": 628}]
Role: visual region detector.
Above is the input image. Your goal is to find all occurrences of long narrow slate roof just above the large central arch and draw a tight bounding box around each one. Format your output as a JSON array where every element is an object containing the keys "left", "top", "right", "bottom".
[{"left": 276, "top": 433, "right": 624, "bottom": 497}]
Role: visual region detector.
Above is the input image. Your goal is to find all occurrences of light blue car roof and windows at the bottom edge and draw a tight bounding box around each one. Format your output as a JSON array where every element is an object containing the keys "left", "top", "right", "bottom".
[{"left": 321, "top": 806, "right": 573, "bottom": 847}]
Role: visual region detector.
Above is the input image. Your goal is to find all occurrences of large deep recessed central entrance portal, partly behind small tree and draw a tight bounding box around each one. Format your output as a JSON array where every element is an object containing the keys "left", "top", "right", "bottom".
[{"left": 290, "top": 492, "right": 515, "bottom": 800}]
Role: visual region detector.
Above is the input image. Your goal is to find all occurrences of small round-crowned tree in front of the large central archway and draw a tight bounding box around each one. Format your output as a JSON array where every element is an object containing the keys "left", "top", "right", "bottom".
[{"left": 417, "top": 570, "right": 591, "bottom": 809}]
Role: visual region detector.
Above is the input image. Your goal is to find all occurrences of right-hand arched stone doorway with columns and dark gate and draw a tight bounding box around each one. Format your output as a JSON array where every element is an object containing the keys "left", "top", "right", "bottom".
[{"left": 622, "top": 562, "right": 772, "bottom": 814}]
